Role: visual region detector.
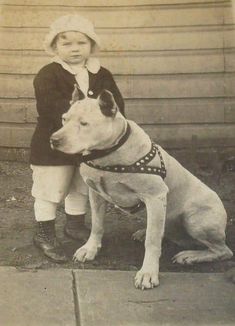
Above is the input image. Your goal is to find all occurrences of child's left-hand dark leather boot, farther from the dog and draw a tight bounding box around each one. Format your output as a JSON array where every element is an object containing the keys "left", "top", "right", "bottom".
[{"left": 33, "top": 220, "right": 68, "bottom": 263}]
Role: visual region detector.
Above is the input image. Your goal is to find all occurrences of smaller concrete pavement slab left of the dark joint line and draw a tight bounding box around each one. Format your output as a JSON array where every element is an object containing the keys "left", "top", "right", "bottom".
[{"left": 0, "top": 267, "right": 76, "bottom": 326}]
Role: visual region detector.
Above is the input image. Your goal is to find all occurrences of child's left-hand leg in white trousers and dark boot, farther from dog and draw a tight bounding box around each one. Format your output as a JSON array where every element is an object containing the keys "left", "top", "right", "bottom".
[{"left": 32, "top": 166, "right": 74, "bottom": 263}]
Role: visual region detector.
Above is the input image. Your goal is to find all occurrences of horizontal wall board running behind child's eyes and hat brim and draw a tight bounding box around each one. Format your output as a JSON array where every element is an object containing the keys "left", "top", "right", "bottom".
[{"left": 0, "top": 26, "right": 226, "bottom": 51}]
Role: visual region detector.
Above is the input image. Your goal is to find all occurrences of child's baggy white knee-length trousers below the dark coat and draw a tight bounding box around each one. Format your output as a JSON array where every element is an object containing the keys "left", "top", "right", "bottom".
[{"left": 31, "top": 165, "right": 88, "bottom": 203}]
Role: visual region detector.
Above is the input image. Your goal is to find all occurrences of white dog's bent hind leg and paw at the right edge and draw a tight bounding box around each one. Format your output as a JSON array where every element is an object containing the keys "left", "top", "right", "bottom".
[{"left": 172, "top": 211, "right": 233, "bottom": 265}]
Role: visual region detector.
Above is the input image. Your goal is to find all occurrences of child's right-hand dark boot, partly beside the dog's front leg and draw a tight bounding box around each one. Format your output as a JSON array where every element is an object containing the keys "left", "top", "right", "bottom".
[{"left": 64, "top": 213, "right": 90, "bottom": 241}]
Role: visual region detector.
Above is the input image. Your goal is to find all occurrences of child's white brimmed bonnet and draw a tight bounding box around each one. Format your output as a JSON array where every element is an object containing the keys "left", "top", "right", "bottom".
[{"left": 44, "top": 15, "right": 100, "bottom": 55}]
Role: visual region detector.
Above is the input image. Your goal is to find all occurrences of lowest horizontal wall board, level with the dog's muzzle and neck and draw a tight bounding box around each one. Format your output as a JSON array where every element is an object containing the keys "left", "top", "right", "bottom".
[{"left": 0, "top": 123, "right": 234, "bottom": 148}]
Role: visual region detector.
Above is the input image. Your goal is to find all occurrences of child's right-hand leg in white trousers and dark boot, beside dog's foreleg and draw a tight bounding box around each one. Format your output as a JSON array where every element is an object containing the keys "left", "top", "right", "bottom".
[{"left": 64, "top": 168, "right": 90, "bottom": 241}]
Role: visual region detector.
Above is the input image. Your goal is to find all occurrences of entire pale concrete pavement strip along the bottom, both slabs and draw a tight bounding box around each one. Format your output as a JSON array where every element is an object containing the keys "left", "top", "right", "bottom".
[{"left": 0, "top": 267, "right": 235, "bottom": 326}]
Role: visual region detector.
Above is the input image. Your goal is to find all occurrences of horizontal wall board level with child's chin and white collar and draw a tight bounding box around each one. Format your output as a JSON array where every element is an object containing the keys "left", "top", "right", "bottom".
[{"left": 0, "top": 49, "right": 226, "bottom": 75}]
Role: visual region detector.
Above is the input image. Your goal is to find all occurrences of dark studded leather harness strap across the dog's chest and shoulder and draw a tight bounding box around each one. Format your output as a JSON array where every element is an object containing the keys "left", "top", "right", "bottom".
[{"left": 84, "top": 142, "right": 166, "bottom": 180}]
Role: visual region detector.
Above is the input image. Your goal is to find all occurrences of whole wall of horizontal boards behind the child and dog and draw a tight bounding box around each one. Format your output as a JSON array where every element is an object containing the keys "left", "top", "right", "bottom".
[{"left": 0, "top": 0, "right": 235, "bottom": 159}]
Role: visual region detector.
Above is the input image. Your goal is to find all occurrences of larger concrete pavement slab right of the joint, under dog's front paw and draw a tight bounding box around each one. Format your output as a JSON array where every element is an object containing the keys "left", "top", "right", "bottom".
[{"left": 75, "top": 270, "right": 235, "bottom": 326}]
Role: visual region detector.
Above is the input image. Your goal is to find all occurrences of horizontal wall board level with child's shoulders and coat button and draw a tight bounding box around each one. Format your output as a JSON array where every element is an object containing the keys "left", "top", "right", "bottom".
[{"left": 0, "top": 73, "right": 235, "bottom": 98}]
